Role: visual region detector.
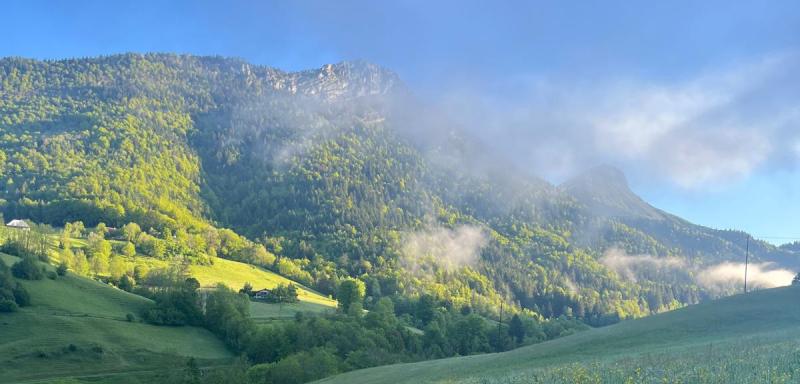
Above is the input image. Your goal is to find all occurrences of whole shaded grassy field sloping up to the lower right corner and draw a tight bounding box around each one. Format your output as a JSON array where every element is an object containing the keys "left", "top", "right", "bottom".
[{"left": 321, "top": 287, "right": 800, "bottom": 384}]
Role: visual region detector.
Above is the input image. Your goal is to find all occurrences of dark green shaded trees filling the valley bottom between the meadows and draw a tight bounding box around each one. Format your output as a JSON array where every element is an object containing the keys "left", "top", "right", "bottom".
[{"left": 139, "top": 269, "right": 585, "bottom": 384}]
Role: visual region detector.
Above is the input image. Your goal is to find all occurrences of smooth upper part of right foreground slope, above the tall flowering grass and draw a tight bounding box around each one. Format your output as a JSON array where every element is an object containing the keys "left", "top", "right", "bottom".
[{"left": 322, "top": 287, "right": 800, "bottom": 384}]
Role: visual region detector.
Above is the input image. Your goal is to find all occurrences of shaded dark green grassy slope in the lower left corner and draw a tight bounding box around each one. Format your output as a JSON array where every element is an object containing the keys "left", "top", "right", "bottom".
[{"left": 0, "top": 255, "right": 231, "bottom": 382}]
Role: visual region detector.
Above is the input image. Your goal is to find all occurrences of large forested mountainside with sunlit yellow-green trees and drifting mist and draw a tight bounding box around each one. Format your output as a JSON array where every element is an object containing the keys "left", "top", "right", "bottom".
[{"left": 0, "top": 54, "right": 797, "bottom": 328}]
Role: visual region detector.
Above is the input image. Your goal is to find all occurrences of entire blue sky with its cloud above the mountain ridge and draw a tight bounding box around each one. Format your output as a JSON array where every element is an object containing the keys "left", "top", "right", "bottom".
[{"left": 0, "top": 0, "right": 800, "bottom": 243}]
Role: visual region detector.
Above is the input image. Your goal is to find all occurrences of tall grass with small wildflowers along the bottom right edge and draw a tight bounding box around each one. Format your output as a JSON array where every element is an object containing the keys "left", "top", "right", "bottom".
[{"left": 459, "top": 337, "right": 800, "bottom": 384}]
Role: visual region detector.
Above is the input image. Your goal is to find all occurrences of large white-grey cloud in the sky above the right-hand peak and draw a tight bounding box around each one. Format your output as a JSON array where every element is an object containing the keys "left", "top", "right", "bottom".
[{"left": 432, "top": 54, "right": 800, "bottom": 188}]
